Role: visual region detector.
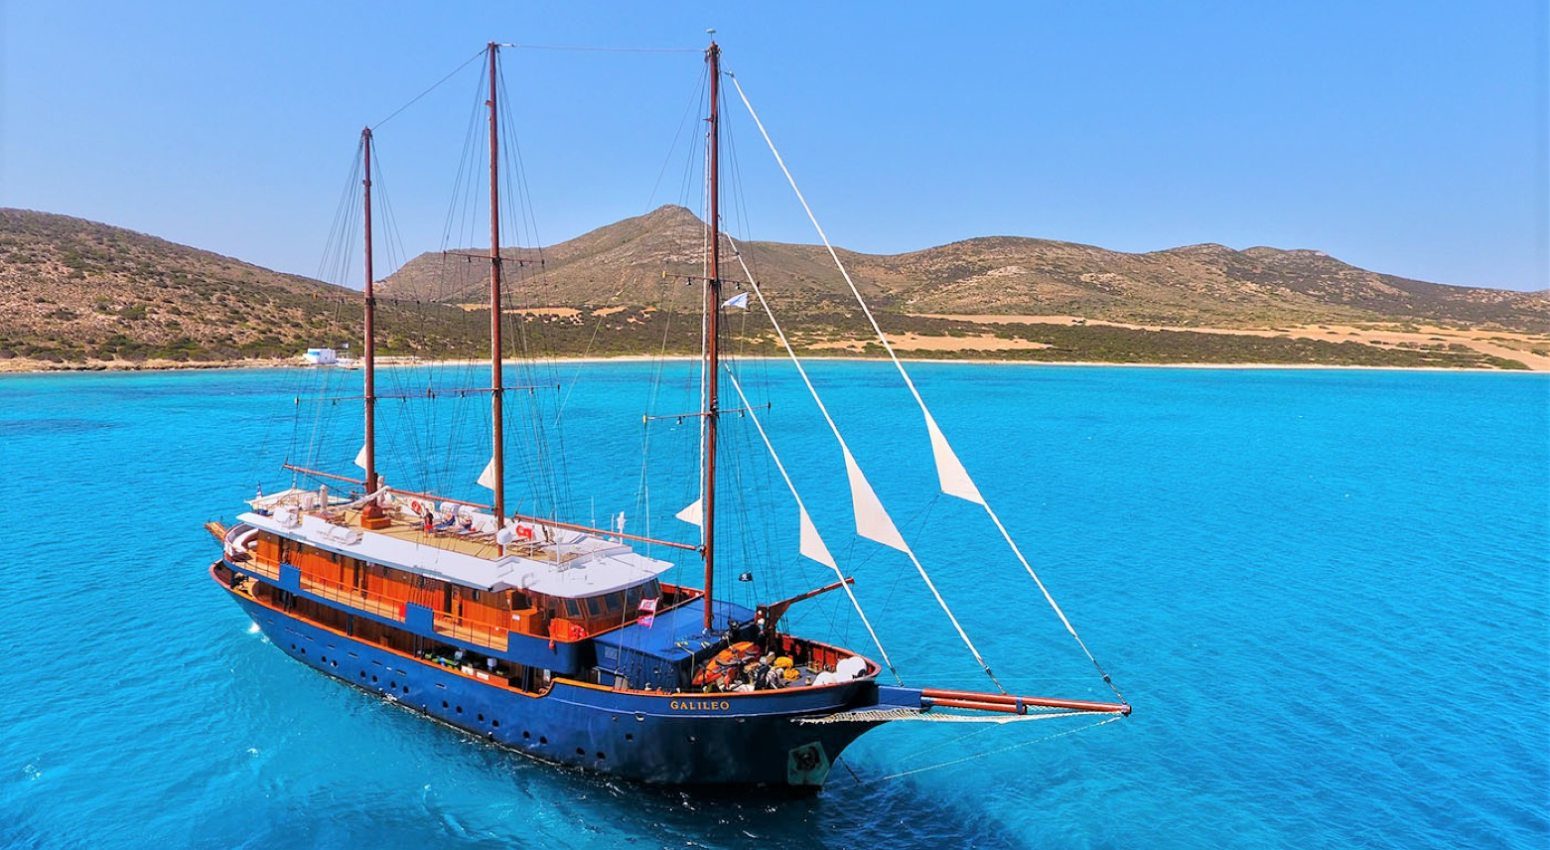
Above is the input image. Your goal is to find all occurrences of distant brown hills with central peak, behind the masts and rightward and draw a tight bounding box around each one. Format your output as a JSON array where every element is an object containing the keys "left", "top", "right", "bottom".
[{"left": 383, "top": 206, "right": 1550, "bottom": 332}]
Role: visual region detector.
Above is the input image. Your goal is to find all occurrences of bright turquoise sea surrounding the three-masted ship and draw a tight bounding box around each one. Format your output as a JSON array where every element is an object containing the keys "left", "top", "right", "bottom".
[{"left": 0, "top": 363, "right": 1550, "bottom": 850}]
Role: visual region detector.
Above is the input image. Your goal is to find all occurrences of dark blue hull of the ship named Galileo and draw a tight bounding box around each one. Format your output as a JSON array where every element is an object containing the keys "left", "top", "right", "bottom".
[{"left": 223, "top": 585, "right": 877, "bottom": 790}]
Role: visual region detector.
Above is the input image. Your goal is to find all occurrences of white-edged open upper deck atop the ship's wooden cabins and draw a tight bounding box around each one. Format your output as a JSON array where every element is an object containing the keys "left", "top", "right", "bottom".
[{"left": 239, "top": 490, "right": 673, "bottom": 599}]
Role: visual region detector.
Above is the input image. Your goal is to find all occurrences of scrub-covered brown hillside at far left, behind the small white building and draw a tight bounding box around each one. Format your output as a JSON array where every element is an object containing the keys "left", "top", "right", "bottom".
[{"left": 0, "top": 209, "right": 471, "bottom": 363}]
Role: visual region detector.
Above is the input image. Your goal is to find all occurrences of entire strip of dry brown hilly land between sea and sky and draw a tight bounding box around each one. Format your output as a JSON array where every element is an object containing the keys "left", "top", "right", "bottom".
[{"left": 0, "top": 206, "right": 1550, "bottom": 371}]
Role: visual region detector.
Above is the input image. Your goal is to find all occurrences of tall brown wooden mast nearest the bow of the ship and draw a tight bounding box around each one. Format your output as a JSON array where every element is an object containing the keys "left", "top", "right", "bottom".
[{"left": 704, "top": 39, "right": 721, "bottom": 631}]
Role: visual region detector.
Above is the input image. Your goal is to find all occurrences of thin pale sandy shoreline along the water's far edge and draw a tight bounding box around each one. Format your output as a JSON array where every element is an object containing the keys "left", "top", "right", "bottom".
[{"left": 0, "top": 354, "right": 1545, "bottom": 378}]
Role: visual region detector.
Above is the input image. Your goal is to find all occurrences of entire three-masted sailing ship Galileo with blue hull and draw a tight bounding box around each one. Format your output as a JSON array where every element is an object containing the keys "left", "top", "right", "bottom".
[{"left": 208, "top": 42, "right": 1130, "bottom": 790}]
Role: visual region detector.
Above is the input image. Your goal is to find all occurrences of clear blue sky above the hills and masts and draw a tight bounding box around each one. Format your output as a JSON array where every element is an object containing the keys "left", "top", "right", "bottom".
[{"left": 0, "top": 0, "right": 1550, "bottom": 289}]
